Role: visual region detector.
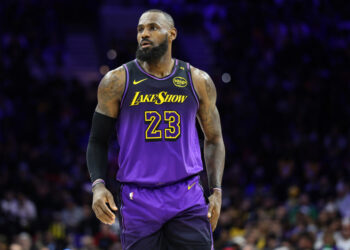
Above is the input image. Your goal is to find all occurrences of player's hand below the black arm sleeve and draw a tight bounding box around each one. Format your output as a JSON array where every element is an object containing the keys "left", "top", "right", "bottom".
[{"left": 92, "top": 183, "right": 118, "bottom": 225}]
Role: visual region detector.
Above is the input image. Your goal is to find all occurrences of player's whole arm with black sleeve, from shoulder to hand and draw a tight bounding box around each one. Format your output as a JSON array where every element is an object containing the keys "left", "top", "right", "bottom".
[{"left": 86, "top": 67, "right": 125, "bottom": 224}]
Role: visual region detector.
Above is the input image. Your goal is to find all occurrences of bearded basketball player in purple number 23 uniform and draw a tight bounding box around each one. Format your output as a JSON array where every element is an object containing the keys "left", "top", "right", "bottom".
[{"left": 87, "top": 10, "right": 225, "bottom": 250}]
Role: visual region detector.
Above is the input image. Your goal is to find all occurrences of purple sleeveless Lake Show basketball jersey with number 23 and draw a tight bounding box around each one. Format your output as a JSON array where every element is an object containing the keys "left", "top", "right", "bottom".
[{"left": 117, "top": 60, "right": 203, "bottom": 186}]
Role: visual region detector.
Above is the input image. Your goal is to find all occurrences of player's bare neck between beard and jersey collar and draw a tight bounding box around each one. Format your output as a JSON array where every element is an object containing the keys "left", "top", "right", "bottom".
[{"left": 139, "top": 53, "right": 175, "bottom": 78}]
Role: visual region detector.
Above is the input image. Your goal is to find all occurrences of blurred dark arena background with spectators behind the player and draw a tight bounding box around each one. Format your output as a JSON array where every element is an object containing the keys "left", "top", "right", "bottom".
[{"left": 0, "top": 0, "right": 350, "bottom": 250}]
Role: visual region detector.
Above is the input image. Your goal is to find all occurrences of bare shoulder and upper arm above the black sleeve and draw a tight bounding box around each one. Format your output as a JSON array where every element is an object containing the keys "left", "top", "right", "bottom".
[{"left": 96, "top": 66, "right": 126, "bottom": 118}]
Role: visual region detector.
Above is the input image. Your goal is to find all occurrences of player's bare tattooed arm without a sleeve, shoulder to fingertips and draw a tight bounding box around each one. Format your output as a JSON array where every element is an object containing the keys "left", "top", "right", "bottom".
[{"left": 191, "top": 67, "right": 225, "bottom": 231}]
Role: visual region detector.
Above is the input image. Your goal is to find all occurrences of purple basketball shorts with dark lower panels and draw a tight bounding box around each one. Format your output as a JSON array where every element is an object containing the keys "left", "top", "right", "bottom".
[{"left": 116, "top": 176, "right": 213, "bottom": 250}]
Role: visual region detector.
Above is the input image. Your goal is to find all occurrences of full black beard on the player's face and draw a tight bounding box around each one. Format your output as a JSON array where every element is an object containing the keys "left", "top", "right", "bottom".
[{"left": 136, "top": 35, "right": 168, "bottom": 63}]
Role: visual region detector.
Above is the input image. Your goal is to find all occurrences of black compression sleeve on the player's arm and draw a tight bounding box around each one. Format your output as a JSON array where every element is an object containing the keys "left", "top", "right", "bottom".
[{"left": 86, "top": 112, "right": 117, "bottom": 182}]
